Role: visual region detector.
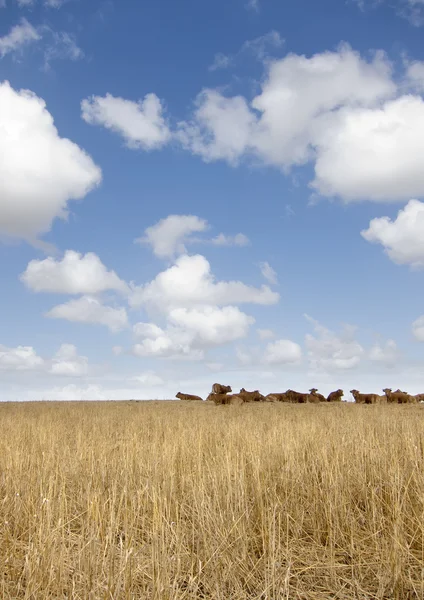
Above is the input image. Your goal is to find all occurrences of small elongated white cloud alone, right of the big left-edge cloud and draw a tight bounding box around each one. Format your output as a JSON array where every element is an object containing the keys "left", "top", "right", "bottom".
[{"left": 81, "top": 94, "right": 171, "bottom": 150}]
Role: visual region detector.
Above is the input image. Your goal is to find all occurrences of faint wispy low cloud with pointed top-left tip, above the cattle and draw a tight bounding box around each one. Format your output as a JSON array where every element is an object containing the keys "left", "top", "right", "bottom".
[{"left": 305, "top": 315, "right": 364, "bottom": 371}]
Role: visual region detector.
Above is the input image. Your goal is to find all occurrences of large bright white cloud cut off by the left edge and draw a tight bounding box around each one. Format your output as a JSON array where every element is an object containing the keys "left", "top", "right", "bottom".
[{"left": 0, "top": 81, "right": 101, "bottom": 242}]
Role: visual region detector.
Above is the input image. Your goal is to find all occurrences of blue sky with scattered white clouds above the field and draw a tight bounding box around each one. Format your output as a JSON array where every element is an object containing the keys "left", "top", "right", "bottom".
[{"left": 0, "top": 0, "right": 424, "bottom": 400}]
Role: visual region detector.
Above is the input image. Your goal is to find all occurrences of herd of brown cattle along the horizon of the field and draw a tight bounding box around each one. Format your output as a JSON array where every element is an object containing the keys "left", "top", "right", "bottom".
[{"left": 176, "top": 383, "right": 424, "bottom": 405}]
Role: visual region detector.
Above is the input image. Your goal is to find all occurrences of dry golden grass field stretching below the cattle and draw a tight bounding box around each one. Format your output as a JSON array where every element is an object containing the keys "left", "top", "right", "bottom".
[{"left": 0, "top": 402, "right": 424, "bottom": 600}]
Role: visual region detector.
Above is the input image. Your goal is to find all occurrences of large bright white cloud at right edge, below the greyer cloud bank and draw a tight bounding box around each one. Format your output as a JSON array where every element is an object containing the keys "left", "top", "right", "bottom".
[{"left": 312, "top": 96, "right": 424, "bottom": 202}]
